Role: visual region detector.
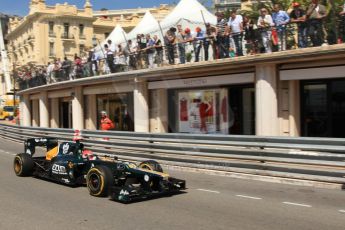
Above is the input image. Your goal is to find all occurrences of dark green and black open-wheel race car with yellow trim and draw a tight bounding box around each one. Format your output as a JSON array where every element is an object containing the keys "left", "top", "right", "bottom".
[{"left": 13, "top": 138, "right": 186, "bottom": 203}]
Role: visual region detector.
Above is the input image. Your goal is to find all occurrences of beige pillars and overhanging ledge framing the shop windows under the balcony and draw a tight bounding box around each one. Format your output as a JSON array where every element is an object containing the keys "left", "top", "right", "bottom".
[{"left": 20, "top": 46, "right": 345, "bottom": 136}]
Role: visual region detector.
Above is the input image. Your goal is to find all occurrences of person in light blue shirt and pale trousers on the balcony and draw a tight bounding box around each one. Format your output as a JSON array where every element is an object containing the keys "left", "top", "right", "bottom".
[{"left": 272, "top": 4, "right": 290, "bottom": 51}]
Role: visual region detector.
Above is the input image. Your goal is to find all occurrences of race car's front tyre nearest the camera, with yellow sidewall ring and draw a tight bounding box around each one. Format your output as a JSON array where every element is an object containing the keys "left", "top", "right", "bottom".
[{"left": 86, "top": 165, "right": 113, "bottom": 197}]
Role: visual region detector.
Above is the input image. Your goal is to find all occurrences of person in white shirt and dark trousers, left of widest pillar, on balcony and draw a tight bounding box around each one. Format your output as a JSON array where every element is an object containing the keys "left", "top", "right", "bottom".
[{"left": 228, "top": 10, "right": 243, "bottom": 56}]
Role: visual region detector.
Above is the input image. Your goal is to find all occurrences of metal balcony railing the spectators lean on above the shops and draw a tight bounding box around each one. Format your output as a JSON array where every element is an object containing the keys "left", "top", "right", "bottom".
[{"left": 16, "top": 16, "right": 345, "bottom": 90}]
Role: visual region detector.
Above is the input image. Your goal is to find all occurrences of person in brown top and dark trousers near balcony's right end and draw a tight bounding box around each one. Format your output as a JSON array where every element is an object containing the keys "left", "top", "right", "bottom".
[{"left": 306, "top": 0, "right": 327, "bottom": 47}]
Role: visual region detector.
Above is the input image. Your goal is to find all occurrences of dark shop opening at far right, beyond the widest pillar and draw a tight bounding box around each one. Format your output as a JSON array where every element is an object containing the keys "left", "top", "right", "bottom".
[{"left": 301, "top": 80, "right": 345, "bottom": 137}]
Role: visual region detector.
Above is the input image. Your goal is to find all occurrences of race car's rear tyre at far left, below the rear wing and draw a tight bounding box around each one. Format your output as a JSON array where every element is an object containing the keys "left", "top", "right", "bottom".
[{"left": 13, "top": 153, "right": 35, "bottom": 177}]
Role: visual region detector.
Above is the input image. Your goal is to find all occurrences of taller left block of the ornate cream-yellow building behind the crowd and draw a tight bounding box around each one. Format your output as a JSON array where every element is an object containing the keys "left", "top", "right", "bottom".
[{"left": 6, "top": 0, "right": 95, "bottom": 68}]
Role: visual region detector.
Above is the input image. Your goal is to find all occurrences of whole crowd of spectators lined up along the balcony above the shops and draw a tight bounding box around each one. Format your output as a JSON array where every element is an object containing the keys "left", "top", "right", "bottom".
[{"left": 17, "top": 0, "right": 345, "bottom": 89}]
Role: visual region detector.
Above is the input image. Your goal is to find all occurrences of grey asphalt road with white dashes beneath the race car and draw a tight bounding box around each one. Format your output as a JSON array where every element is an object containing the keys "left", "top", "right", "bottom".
[{"left": 0, "top": 137, "right": 345, "bottom": 230}]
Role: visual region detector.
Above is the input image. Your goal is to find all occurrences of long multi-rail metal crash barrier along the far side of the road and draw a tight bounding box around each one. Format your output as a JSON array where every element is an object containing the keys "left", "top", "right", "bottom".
[{"left": 0, "top": 125, "right": 345, "bottom": 188}]
